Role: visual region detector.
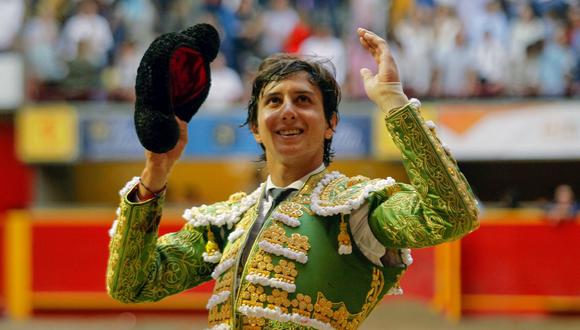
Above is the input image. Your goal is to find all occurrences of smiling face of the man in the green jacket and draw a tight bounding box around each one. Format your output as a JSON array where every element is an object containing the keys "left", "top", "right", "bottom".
[{"left": 252, "top": 72, "right": 337, "bottom": 166}]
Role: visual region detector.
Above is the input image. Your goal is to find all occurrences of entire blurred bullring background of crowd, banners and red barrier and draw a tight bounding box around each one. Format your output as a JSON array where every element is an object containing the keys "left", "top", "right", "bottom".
[{"left": 0, "top": 0, "right": 580, "bottom": 329}]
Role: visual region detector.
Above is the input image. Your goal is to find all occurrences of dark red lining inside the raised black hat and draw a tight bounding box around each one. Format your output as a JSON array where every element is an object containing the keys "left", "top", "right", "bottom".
[{"left": 169, "top": 46, "right": 208, "bottom": 106}]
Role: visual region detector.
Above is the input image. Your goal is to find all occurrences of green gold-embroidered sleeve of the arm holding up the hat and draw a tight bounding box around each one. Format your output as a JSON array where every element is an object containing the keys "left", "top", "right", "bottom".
[{"left": 107, "top": 192, "right": 214, "bottom": 303}]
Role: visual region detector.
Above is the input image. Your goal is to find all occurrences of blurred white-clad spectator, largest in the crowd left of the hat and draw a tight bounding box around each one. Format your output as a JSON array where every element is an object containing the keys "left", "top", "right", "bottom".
[{"left": 61, "top": 0, "right": 113, "bottom": 68}]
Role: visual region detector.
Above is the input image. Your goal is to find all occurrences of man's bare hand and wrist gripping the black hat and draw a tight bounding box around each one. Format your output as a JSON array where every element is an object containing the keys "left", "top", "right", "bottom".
[{"left": 139, "top": 117, "right": 187, "bottom": 200}]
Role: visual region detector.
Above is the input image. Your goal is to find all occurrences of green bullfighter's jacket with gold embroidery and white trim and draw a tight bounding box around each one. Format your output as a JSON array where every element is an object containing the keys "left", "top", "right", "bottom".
[{"left": 107, "top": 101, "right": 478, "bottom": 329}]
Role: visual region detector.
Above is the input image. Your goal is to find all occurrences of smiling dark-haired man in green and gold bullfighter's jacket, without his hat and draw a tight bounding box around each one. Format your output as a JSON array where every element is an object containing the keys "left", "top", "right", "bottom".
[{"left": 107, "top": 29, "right": 478, "bottom": 329}]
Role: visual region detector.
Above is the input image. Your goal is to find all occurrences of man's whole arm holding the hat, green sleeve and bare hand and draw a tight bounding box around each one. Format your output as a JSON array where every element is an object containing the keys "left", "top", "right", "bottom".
[{"left": 107, "top": 119, "right": 213, "bottom": 302}]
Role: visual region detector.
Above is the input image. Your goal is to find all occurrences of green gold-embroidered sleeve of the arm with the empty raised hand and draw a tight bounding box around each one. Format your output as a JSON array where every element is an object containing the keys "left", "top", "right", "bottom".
[{"left": 369, "top": 101, "right": 479, "bottom": 248}]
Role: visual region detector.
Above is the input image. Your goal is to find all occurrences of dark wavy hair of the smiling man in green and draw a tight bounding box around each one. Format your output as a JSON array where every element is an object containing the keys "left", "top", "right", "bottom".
[{"left": 242, "top": 54, "right": 341, "bottom": 166}]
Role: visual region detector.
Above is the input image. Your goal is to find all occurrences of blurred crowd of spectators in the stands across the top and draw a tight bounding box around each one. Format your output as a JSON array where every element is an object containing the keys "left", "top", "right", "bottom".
[{"left": 0, "top": 0, "right": 580, "bottom": 108}]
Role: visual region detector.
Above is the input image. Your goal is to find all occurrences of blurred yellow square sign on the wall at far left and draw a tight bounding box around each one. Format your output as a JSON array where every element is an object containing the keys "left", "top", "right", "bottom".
[{"left": 16, "top": 105, "right": 79, "bottom": 163}]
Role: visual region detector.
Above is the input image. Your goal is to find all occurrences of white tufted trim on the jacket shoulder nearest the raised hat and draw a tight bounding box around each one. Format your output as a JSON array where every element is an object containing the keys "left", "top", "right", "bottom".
[{"left": 182, "top": 183, "right": 264, "bottom": 228}]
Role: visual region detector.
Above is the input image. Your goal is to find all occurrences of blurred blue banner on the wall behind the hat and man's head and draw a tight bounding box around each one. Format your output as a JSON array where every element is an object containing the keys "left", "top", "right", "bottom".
[{"left": 80, "top": 112, "right": 371, "bottom": 161}]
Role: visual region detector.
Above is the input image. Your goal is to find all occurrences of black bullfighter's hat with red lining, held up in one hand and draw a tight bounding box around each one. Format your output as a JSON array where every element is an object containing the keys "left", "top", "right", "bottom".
[{"left": 135, "top": 24, "right": 220, "bottom": 153}]
